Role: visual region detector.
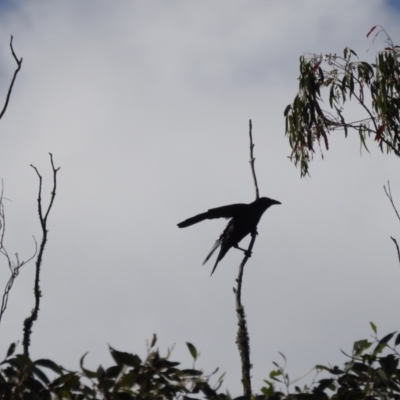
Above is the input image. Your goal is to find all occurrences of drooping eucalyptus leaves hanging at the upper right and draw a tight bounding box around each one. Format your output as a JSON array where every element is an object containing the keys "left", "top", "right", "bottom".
[{"left": 284, "top": 27, "right": 400, "bottom": 176}]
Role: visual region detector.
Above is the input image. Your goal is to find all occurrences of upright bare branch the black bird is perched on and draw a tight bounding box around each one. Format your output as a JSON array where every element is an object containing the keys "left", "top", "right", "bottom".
[{"left": 233, "top": 120, "right": 259, "bottom": 400}]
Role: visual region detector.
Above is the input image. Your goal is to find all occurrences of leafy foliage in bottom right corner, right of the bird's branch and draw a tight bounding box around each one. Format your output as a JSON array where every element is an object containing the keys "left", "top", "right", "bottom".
[{"left": 258, "top": 323, "right": 400, "bottom": 400}]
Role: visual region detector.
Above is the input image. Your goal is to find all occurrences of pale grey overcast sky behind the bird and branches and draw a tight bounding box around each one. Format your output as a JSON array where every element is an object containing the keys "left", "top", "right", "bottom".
[{"left": 0, "top": 0, "right": 400, "bottom": 395}]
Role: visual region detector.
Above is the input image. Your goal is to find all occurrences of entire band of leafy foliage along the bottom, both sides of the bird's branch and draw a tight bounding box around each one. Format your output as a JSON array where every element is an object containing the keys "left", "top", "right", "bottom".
[{"left": 0, "top": 323, "right": 400, "bottom": 400}]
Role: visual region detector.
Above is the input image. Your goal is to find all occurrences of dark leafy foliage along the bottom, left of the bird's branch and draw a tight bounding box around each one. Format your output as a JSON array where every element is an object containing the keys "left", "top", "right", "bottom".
[{"left": 0, "top": 336, "right": 230, "bottom": 400}]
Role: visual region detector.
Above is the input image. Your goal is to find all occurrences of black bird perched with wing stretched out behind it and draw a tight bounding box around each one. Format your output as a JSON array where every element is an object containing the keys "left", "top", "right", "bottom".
[{"left": 178, "top": 197, "right": 281, "bottom": 275}]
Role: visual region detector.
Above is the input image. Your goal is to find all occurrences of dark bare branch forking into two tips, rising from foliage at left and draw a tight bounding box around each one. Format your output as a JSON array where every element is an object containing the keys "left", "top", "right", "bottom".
[{"left": 22, "top": 153, "right": 60, "bottom": 356}]
